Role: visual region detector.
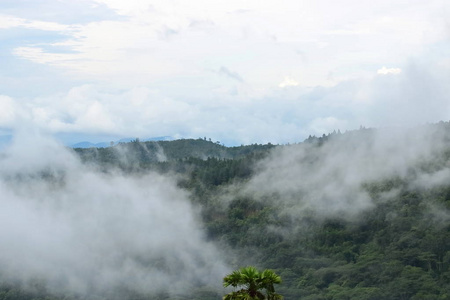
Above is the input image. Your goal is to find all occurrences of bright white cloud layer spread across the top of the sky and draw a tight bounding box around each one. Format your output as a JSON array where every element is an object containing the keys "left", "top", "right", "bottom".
[{"left": 3, "top": 0, "right": 448, "bottom": 89}]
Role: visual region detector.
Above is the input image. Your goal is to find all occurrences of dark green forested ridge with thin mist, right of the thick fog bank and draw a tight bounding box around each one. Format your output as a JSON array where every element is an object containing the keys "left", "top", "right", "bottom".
[{"left": 0, "top": 122, "right": 450, "bottom": 300}]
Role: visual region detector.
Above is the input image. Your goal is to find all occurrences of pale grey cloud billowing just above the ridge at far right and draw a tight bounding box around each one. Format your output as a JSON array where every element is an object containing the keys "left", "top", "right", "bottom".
[{"left": 365, "top": 61, "right": 450, "bottom": 126}]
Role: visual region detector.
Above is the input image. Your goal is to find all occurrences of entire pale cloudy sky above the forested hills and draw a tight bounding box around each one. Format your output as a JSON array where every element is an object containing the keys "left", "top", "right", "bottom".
[{"left": 0, "top": 0, "right": 450, "bottom": 145}]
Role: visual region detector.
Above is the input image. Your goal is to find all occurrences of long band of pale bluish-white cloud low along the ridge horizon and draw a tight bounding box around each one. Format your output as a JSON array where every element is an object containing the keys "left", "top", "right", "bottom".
[{"left": 0, "top": 56, "right": 450, "bottom": 145}]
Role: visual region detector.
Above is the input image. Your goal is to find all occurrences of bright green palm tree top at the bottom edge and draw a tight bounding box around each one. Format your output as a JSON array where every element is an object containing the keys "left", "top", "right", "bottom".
[{"left": 223, "top": 266, "right": 283, "bottom": 300}]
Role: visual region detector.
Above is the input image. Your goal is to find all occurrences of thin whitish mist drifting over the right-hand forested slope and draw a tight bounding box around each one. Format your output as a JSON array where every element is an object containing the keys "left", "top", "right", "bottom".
[{"left": 241, "top": 124, "right": 450, "bottom": 220}]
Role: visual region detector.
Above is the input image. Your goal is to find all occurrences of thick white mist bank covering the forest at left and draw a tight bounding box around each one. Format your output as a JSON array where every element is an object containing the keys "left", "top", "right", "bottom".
[{"left": 0, "top": 134, "right": 229, "bottom": 294}]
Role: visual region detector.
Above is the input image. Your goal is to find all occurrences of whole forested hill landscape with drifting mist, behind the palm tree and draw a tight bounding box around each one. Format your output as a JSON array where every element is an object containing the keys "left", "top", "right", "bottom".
[{"left": 0, "top": 122, "right": 450, "bottom": 300}]
